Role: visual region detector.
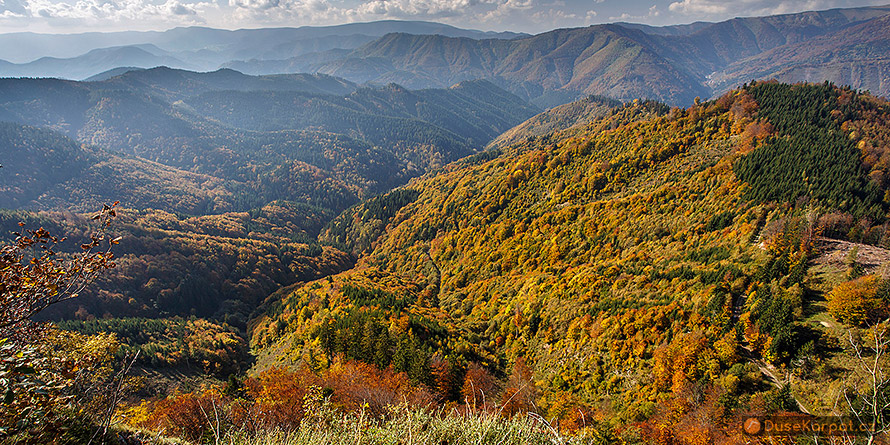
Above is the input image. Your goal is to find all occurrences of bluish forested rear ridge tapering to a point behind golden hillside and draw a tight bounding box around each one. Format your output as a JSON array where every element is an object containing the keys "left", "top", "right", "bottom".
[{"left": 184, "top": 81, "right": 539, "bottom": 169}]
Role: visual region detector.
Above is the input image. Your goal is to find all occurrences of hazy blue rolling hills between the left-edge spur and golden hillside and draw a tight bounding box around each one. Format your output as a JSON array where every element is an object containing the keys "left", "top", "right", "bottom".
[{"left": 0, "top": 68, "right": 537, "bottom": 205}]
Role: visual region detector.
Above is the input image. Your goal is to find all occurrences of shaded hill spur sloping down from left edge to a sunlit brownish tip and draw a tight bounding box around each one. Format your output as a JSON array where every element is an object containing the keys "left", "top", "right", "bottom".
[{"left": 0, "top": 122, "right": 238, "bottom": 214}]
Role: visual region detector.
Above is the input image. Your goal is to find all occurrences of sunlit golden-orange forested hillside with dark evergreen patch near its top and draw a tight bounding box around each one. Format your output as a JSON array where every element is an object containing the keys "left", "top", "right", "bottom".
[{"left": 232, "top": 83, "right": 890, "bottom": 443}]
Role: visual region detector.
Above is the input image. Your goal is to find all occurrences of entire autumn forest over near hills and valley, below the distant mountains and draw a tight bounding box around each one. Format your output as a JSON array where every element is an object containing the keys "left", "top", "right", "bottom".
[{"left": 0, "top": 10, "right": 890, "bottom": 445}]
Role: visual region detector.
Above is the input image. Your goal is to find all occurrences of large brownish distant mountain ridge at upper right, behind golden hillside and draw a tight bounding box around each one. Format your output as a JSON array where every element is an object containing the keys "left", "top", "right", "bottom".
[{"left": 301, "top": 6, "right": 890, "bottom": 106}]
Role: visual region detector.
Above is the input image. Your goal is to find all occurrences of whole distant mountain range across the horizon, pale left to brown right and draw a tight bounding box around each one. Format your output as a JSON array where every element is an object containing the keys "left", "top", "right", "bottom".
[{"left": 0, "top": 6, "right": 890, "bottom": 107}]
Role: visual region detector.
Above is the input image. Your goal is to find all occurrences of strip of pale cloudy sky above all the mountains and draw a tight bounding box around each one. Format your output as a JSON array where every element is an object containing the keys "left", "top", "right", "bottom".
[{"left": 0, "top": 0, "right": 890, "bottom": 33}]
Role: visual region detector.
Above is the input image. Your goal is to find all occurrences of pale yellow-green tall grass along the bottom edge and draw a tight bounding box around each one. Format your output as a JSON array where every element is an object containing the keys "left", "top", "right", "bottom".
[{"left": 220, "top": 405, "right": 617, "bottom": 445}]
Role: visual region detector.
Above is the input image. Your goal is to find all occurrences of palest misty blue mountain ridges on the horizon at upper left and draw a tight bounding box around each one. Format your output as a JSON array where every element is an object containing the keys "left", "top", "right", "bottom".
[{"left": 0, "top": 20, "right": 525, "bottom": 80}]
